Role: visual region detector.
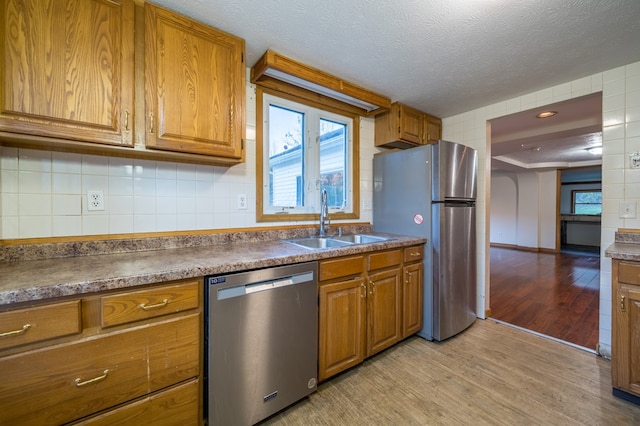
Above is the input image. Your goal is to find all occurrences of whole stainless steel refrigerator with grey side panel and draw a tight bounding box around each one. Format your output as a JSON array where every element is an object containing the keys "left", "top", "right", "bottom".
[{"left": 373, "top": 140, "right": 478, "bottom": 340}]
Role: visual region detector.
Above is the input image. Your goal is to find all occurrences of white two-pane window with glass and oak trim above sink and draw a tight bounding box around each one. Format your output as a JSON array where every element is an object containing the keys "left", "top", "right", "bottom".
[{"left": 256, "top": 87, "right": 359, "bottom": 221}]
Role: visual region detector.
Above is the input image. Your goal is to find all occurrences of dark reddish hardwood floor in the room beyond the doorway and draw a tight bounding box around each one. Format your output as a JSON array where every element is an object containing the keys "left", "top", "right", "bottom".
[{"left": 490, "top": 247, "right": 600, "bottom": 350}]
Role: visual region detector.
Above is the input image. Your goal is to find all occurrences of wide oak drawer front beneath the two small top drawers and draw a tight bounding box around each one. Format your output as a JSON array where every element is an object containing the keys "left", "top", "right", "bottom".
[{"left": 0, "top": 313, "right": 201, "bottom": 425}]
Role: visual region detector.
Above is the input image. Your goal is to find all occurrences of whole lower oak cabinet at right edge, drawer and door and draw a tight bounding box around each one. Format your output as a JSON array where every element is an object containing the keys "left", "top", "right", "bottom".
[{"left": 611, "top": 259, "right": 640, "bottom": 397}]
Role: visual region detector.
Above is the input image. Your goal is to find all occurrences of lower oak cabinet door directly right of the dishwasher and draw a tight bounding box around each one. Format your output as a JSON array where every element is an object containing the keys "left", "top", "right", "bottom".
[{"left": 318, "top": 278, "right": 367, "bottom": 380}]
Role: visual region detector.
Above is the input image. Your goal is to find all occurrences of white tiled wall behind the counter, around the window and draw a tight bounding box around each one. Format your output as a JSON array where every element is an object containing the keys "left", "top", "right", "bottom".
[{"left": 0, "top": 80, "right": 377, "bottom": 239}]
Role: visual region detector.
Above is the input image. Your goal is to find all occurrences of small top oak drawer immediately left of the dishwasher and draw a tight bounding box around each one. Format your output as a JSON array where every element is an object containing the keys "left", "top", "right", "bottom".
[{"left": 101, "top": 280, "right": 200, "bottom": 327}]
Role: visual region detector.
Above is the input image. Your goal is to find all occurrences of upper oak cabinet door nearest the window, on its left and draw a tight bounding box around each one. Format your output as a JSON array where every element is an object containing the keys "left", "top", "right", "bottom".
[{"left": 144, "top": 3, "right": 245, "bottom": 160}]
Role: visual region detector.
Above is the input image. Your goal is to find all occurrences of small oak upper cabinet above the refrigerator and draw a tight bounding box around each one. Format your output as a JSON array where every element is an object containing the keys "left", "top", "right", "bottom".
[{"left": 375, "top": 102, "right": 442, "bottom": 148}]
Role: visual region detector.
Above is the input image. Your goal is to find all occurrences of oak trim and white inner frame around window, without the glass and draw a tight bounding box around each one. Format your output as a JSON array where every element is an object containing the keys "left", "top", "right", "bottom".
[{"left": 256, "top": 85, "right": 360, "bottom": 222}]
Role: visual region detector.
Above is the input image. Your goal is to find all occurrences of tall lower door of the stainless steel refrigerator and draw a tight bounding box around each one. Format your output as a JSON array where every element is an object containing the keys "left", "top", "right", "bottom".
[{"left": 432, "top": 203, "right": 477, "bottom": 340}]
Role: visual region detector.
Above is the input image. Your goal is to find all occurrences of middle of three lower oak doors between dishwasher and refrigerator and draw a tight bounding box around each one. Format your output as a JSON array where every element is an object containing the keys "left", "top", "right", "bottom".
[{"left": 367, "top": 269, "right": 402, "bottom": 356}]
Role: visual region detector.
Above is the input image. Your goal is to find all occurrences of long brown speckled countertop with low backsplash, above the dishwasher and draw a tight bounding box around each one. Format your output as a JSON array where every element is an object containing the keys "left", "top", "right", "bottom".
[{"left": 0, "top": 229, "right": 426, "bottom": 305}]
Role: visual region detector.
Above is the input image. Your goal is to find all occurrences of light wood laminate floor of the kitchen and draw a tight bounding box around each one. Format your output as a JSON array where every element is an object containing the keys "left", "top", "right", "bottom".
[{"left": 262, "top": 319, "right": 640, "bottom": 426}]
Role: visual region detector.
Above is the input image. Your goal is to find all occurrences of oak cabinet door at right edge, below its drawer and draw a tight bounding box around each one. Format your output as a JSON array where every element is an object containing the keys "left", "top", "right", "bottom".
[{"left": 612, "top": 284, "right": 640, "bottom": 395}]
